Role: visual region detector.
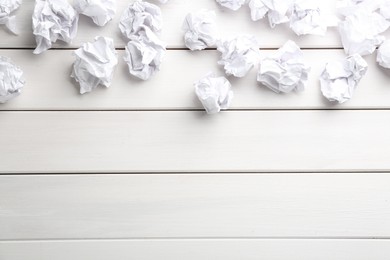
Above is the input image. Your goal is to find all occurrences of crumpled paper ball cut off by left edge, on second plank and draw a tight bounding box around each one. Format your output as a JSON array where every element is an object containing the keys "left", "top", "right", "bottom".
[{"left": 0, "top": 56, "right": 25, "bottom": 103}]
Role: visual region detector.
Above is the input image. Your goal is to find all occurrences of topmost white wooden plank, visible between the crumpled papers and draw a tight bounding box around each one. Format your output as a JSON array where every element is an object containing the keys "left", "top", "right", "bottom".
[{"left": 0, "top": 0, "right": 341, "bottom": 48}]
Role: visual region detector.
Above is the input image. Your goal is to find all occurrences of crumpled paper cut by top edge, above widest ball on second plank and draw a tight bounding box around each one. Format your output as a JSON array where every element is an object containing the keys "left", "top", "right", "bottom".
[{"left": 249, "top": 0, "right": 293, "bottom": 28}]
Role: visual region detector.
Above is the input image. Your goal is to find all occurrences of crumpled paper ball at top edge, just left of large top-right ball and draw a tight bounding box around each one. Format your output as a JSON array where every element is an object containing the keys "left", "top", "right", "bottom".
[{"left": 290, "top": 0, "right": 328, "bottom": 35}]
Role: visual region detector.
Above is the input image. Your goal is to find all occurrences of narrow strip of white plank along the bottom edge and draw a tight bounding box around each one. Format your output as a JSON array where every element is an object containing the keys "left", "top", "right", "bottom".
[{"left": 0, "top": 239, "right": 390, "bottom": 260}]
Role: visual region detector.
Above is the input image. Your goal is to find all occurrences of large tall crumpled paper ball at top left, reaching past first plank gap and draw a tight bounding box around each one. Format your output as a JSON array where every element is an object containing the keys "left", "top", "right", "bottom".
[{"left": 32, "top": 0, "right": 79, "bottom": 54}]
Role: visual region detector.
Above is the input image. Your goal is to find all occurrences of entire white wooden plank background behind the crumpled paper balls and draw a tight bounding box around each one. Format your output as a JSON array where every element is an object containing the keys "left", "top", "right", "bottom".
[{"left": 0, "top": 0, "right": 390, "bottom": 260}]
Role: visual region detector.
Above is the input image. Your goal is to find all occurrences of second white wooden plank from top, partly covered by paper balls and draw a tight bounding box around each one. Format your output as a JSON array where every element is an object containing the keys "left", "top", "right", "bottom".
[{"left": 0, "top": 50, "right": 390, "bottom": 110}]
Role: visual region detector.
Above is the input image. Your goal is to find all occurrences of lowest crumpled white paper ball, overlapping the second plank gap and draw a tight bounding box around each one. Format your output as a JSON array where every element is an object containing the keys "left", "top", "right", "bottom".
[{"left": 194, "top": 72, "right": 233, "bottom": 114}]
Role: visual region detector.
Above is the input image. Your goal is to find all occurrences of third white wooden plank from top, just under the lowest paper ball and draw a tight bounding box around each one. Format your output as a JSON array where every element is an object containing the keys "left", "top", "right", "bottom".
[{"left": 0, "top": 111, "right": 390, "bottom": 173}]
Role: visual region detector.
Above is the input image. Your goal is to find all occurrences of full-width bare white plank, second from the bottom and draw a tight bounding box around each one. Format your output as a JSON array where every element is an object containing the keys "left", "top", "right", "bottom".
[{"left": 0, "top": 173, "right": 390, "bottom": 240}]
